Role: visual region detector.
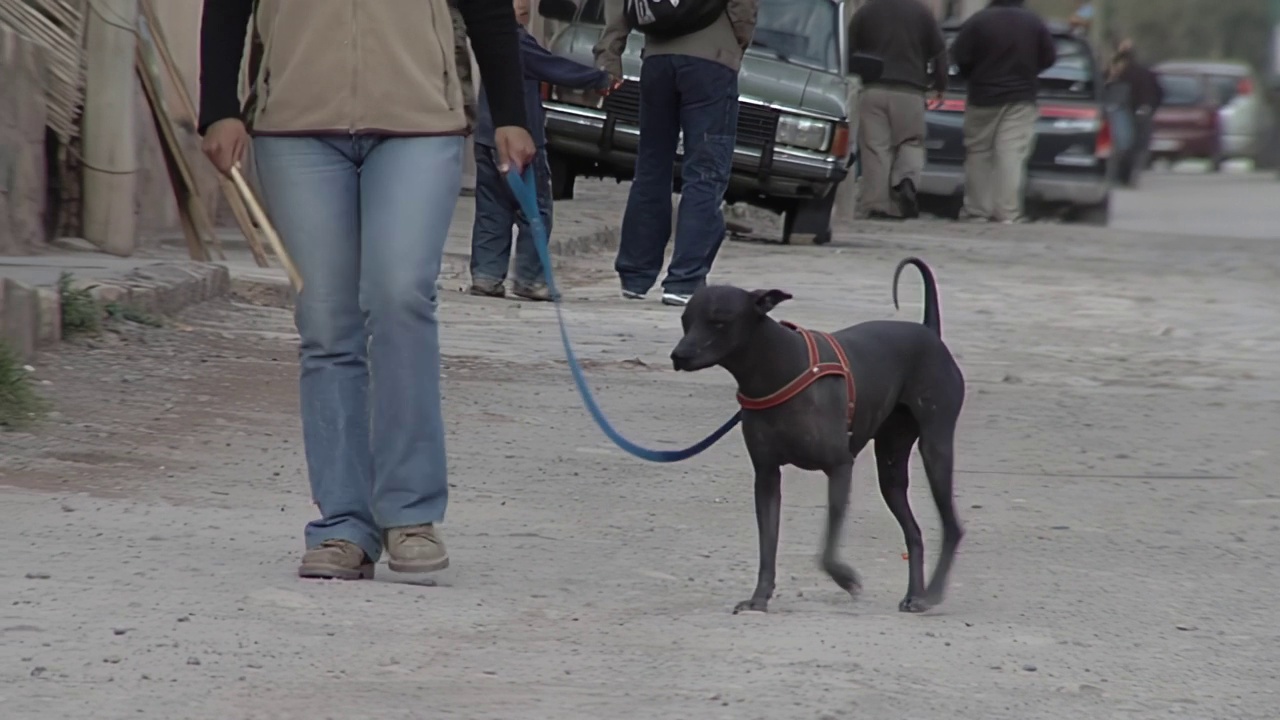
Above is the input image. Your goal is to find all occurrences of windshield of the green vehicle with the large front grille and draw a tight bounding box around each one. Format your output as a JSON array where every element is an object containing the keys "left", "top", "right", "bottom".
[{"left": 751, "top": 0, "right": 840, "bottom": 73}]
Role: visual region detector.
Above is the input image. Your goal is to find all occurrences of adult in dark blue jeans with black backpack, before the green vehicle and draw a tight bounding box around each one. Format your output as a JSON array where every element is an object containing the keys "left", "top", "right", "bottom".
[{"left": 595, "top": 0, "right": 759, "bottom": 305}]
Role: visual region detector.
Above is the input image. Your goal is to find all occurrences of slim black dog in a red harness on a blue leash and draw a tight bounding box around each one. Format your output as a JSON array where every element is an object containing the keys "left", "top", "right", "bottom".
[{"left": 671, "top": 258, "right": 965, "bottom": 612}]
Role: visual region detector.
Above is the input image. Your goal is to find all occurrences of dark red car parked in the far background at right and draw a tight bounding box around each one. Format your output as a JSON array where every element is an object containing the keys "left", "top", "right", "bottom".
[{"left": 1151, "top": 72, "right": 1225, "bottom": 170}]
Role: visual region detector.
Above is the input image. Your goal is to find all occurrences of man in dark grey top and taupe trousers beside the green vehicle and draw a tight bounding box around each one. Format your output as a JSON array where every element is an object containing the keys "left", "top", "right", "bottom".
[{"left": 849, "top": 0, "right": 948, "bottom": 219}]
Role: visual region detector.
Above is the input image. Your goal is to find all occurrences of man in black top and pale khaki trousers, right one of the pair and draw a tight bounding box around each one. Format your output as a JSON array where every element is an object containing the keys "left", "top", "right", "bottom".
[{"left": 951, "top": 0, "right": 1057, "bottom": 223}]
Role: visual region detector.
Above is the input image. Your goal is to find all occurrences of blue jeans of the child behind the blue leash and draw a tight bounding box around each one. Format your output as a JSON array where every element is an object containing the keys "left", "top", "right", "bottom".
[{"left": 471, "top": 143, "right": 552, "bottom": 286}]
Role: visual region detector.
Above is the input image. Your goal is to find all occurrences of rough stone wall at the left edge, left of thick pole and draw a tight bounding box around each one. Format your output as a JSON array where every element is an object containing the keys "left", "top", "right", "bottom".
[{"left": 0, "top": 26, "right": 47, "bottom": 256}]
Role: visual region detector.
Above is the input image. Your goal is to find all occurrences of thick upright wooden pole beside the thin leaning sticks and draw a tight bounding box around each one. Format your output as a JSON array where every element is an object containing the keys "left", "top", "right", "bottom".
[{"left": 82, "top": 0, "right": 138, "bottom": 256}]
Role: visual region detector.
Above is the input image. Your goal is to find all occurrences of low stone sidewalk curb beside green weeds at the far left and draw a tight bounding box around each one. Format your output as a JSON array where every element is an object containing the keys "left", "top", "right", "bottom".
[{"left": 0, "top": 261, "right": 232, "bottom": 361}]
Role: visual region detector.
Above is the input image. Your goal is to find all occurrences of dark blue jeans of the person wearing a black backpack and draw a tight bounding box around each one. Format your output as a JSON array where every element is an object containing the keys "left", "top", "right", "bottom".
[{"left": 614, "top": 55, "right": 737, "bottom": 295}]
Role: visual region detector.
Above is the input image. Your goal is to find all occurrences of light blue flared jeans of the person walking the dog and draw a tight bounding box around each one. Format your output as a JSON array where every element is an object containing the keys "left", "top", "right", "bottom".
[{"left": 253, "top": 136, "right": 463, "bottom": 561}]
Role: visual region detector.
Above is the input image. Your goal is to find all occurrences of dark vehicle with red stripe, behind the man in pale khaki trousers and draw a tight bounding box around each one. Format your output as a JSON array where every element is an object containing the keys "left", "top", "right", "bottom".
[{"left": 919, "top": 20, "right": 1114, "bottom": 225}]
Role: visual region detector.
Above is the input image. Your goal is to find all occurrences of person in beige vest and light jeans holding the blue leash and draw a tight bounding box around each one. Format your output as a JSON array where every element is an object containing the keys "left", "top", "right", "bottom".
[{"left": 200, "top": 0, "right": 535, "bottom": 579}]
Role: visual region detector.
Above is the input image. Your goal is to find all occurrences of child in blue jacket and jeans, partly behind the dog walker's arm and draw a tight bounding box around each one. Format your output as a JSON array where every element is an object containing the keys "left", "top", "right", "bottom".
[{"left": 471, "top": 0, "right": 614, "bottom": 301}]
